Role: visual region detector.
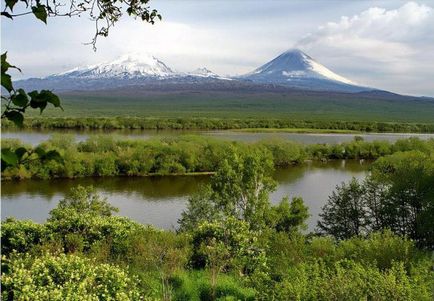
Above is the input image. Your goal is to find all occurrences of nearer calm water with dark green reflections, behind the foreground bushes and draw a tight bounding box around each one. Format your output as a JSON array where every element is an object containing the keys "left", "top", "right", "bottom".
[{"left": 1, "top": 161, "right": 368, "bottom": 230}]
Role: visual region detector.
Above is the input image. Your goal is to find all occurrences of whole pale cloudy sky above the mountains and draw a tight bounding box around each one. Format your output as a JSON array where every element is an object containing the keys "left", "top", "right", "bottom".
[{"left": 1, "top": 0, "right": 434, "bottom": 96}]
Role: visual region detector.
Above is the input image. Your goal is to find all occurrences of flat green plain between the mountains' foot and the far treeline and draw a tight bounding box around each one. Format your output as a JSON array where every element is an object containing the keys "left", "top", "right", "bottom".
[{"left": 19, "top": 92, "right": 434, "bottom": 124}]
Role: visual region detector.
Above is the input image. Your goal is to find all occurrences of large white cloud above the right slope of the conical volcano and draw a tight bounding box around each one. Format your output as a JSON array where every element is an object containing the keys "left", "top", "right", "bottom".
[{"left": 297, "top": 2, "right": 434, "bottom": 95}]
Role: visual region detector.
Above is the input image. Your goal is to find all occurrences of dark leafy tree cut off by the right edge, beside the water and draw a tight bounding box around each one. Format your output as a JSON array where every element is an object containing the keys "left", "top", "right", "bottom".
[{"left": 372, "top": 150, "right": 434, "bottom": 249}]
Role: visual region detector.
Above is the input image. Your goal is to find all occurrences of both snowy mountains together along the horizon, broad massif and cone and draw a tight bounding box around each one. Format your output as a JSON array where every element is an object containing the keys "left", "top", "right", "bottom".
[{"left": 15, "top": 49, "right": 380, "bottom": 93}]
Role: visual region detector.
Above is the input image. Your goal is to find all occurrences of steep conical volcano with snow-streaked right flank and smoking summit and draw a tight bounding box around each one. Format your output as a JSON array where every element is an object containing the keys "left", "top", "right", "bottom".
[{"left": 240, "top": 49, "right": 367, "bottom": 92}]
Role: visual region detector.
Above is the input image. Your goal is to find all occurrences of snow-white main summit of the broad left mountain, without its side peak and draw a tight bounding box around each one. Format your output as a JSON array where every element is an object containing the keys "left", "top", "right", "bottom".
[{"left": 50, "top": 54, "right": 175, "bottom": 79}]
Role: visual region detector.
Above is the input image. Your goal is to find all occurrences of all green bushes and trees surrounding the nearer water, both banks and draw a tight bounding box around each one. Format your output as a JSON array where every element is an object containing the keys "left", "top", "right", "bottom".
[{"left": 1, "top": 135, "right": 434, "bottom": 300}]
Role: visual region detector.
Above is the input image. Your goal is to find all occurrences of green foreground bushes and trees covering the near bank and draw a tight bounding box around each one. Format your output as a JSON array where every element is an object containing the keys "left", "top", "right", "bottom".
[{"left": 1, "top": 148, "right": 434, "bottom": 301}]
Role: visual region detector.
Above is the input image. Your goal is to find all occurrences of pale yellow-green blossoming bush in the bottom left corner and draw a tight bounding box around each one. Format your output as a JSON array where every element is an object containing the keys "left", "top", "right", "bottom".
[{"left": 2, "top": 254, "right": 141, "bottom": 301}]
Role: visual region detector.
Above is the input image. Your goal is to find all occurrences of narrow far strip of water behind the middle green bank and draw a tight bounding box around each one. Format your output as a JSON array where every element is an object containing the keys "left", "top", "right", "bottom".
[{"left": 2, "top": 129, "right": 434, "bottom": 145}]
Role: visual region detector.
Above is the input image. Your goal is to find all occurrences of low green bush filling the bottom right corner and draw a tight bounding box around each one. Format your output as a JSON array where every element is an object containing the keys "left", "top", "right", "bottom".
[{"left": 273, "top": 260, "right": 432, "bottom": 301}]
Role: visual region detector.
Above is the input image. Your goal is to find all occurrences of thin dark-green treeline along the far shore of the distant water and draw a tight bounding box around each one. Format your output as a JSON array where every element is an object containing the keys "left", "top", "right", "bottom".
[{"left": 2, "top": 117, "right": 434, "bottom": 133}]
